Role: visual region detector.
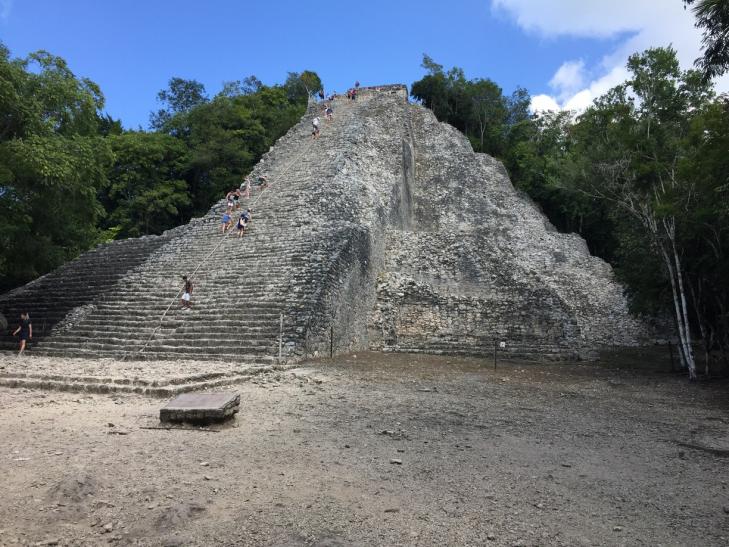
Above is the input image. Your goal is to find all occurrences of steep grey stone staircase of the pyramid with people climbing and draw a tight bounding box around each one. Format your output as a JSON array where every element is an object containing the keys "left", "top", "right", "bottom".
[{"left": 0, "top": 92, "right": 386, "bottom": 362}]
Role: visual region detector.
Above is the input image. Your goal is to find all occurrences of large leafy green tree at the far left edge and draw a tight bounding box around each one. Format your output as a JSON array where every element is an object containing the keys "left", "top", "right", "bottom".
[{"left": 0, "top": 44, "right": 112, "bottom": 289}]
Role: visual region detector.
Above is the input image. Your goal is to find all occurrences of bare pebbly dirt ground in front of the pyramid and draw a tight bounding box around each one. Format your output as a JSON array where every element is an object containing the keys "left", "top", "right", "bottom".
[{"left": 0, "top": 354, "right": 729, "bottom": 547}]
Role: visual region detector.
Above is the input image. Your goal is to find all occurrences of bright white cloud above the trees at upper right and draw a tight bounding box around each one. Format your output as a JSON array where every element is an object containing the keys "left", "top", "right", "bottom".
[{"left": 491, "top": 0, "right": 729, "bottom": 110}]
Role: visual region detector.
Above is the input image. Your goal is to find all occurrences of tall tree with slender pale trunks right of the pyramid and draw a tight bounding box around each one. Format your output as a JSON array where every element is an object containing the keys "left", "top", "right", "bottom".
[{"left": 573, "top": 48, "right": 711, "bottom": 380}]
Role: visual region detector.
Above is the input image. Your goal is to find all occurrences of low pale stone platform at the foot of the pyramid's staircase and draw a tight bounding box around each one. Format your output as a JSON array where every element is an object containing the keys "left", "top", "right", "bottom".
[{"left": 0, "top": 352, "right": 294, "bottom": 398}]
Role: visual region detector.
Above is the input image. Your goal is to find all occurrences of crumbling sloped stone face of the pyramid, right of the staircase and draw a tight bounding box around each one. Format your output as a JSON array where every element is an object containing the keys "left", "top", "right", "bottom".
[{"left": 370, "top": 98, "right": 649, "bottom": 359}]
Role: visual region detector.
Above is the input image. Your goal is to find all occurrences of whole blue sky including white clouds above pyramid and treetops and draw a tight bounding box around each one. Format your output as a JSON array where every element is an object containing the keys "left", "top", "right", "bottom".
[{"left": 0, "top": 0, "right": 716, "bottom": 127}]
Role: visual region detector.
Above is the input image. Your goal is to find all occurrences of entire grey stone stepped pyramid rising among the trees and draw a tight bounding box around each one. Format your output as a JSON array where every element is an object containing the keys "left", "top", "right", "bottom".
[{"left": 0, "top": 85, "right": 648, "bottom": 361}]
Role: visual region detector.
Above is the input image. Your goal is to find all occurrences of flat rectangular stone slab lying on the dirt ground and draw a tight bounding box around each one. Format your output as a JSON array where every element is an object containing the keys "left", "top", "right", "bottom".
[{"left": 159, "top": 391, "right": 240, "bottom": 423}]
